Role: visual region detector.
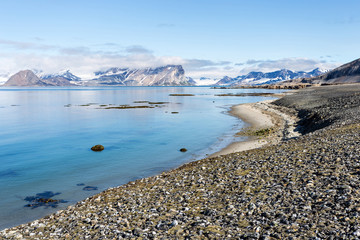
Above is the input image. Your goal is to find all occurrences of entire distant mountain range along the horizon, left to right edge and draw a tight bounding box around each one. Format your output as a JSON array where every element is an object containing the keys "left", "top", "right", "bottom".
[{"left": 2, "top": 59, "right": 360, "bottom": 86}]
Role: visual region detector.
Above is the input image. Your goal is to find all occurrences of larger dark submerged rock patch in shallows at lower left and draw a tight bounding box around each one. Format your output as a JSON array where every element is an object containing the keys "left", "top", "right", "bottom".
[{"left": 24, "top": 191, "right": 67, "bottom": 209}]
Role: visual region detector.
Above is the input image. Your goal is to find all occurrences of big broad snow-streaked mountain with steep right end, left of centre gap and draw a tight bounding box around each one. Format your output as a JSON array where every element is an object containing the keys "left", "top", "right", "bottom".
[{"left": 85, "top": 65, "right": 194, "bottom": 86}]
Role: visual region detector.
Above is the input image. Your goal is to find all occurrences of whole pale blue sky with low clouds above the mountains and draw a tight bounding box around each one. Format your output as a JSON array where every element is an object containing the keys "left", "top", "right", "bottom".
[{"left": 0, "top": 0, "right": 360, "bottom": 80}]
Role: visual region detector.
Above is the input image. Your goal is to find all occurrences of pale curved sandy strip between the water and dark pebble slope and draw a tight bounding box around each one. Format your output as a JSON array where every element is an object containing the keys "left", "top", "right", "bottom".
[{"left": 210, "top": 100, "right": 299, "bottom": 157}]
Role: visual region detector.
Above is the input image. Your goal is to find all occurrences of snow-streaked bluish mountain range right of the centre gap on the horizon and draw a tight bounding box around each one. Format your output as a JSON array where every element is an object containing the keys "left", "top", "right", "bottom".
[{"left": 216, "top": 68, "right": 326, "bottom": 85}]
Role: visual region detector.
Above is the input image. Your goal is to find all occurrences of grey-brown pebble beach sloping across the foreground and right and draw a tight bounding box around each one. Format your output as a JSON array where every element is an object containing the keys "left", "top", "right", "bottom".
[{"left": 0, "top": 84, "right": 360, "bottom": 239}]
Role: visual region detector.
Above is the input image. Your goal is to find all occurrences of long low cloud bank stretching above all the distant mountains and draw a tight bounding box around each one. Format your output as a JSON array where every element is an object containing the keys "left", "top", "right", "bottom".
[{"left": 0, "top": 39, "right": 339, "bottom": 81}]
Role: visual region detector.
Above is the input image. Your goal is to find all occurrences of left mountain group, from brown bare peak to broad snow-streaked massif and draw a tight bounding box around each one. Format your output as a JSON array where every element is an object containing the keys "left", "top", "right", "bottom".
[{"left": 3, "top": 65, "right": 195, "bottom": 86}]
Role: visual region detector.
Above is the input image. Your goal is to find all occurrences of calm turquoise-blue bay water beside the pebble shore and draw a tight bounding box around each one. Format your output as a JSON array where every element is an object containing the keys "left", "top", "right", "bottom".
[{"left": 0, "top": 87, "right": 278, "bottom": 229}]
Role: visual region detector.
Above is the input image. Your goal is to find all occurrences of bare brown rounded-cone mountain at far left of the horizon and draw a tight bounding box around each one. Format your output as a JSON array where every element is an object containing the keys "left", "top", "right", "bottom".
[{"left": 3, "top": 70, "right": 48, "bottom": 87}]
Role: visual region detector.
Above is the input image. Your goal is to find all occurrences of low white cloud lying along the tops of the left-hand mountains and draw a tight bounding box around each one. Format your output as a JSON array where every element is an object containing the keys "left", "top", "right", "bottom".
[{"left": 0, "top": 49, "right": 184, "bottom": 78}]
